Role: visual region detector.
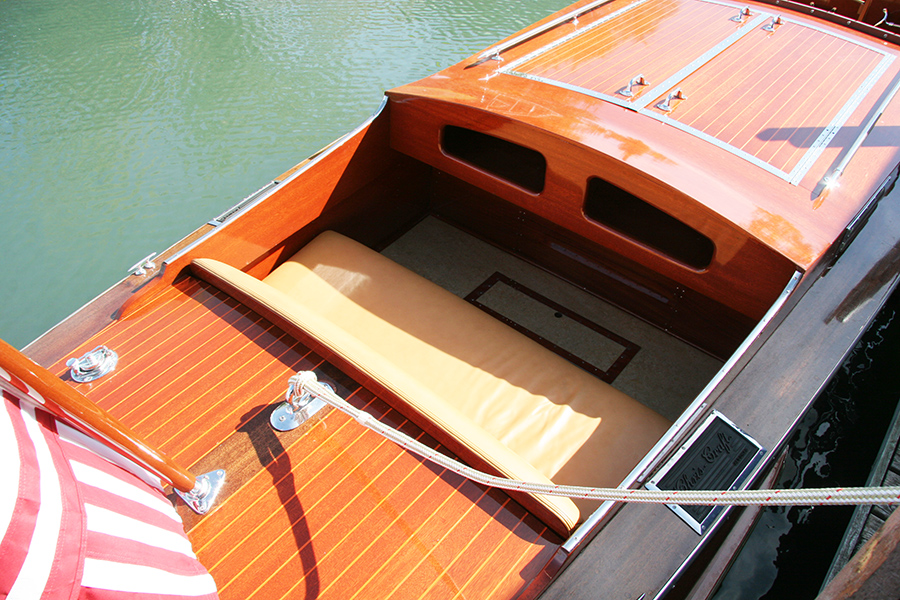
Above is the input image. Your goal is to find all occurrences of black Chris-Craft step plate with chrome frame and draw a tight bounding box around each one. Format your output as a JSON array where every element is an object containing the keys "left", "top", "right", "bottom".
[{"left": 647, "top": 411, "right": 765, "bottom": 534}]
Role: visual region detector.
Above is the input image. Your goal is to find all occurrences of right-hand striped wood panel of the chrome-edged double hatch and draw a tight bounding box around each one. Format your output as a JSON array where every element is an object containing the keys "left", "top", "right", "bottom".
[{"left": 669, "top": 22, "right": 882, "bottom": 173}]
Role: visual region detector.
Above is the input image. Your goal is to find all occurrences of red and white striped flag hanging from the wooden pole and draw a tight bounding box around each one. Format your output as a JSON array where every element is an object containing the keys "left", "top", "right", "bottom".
[{"left": 0, "top": 382, "right": 218, "bottom": 599}]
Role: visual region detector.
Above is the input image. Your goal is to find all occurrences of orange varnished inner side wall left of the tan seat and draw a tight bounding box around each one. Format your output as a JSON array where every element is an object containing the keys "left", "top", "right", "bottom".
[{"left": 110, "top": 108, "right": 428, "bottom": 326}]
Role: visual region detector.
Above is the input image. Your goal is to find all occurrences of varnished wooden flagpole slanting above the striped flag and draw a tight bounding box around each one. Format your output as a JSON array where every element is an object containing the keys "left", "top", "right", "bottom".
[{"left": 0, "top": 340, "right": 197, "bottom": 492}]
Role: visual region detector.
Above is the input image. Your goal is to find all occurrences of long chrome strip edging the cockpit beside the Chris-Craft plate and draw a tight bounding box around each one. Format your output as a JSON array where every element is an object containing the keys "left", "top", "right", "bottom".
[{"left": 562, "top": 271, "right": 803, "bottom": 553}]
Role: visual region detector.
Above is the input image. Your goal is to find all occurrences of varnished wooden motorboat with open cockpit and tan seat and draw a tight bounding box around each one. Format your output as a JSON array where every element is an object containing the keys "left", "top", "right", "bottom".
[{"left": 0, "top": 0, "right": 900, "bottom": 598}]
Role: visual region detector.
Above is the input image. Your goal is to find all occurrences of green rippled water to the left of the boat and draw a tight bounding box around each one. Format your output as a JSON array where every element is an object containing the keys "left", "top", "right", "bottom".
[{"left": 0, "top": 0, "right": 568, "bottom": 347}]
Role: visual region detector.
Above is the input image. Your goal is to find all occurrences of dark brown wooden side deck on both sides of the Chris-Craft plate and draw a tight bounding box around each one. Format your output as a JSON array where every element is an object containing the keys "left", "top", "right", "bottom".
[{"left": 543, "top": 136, "right": 900, "bottom": 600}]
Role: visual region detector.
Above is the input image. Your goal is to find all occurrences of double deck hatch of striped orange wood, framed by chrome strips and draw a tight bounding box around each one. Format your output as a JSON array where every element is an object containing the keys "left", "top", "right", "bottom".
[{"left": 500, "top": 0, "right": 894, "bottom": 185}]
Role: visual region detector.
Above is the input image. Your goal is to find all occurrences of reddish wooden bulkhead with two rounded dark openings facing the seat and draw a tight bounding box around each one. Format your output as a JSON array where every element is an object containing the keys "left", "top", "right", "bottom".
[{"left": 390, "top": 92, "right": 795, "bottom": 320}]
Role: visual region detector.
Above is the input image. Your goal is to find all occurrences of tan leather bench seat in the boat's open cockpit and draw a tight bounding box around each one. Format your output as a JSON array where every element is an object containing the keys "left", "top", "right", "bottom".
[{"left": 195, "top": 232, "right": 670, "bottom": 529}]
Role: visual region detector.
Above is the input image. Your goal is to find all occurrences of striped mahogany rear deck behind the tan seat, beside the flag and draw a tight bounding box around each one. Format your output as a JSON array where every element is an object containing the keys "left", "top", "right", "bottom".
[{"left": 51, "top": 279, "right": 560, "bottom": 600}]
